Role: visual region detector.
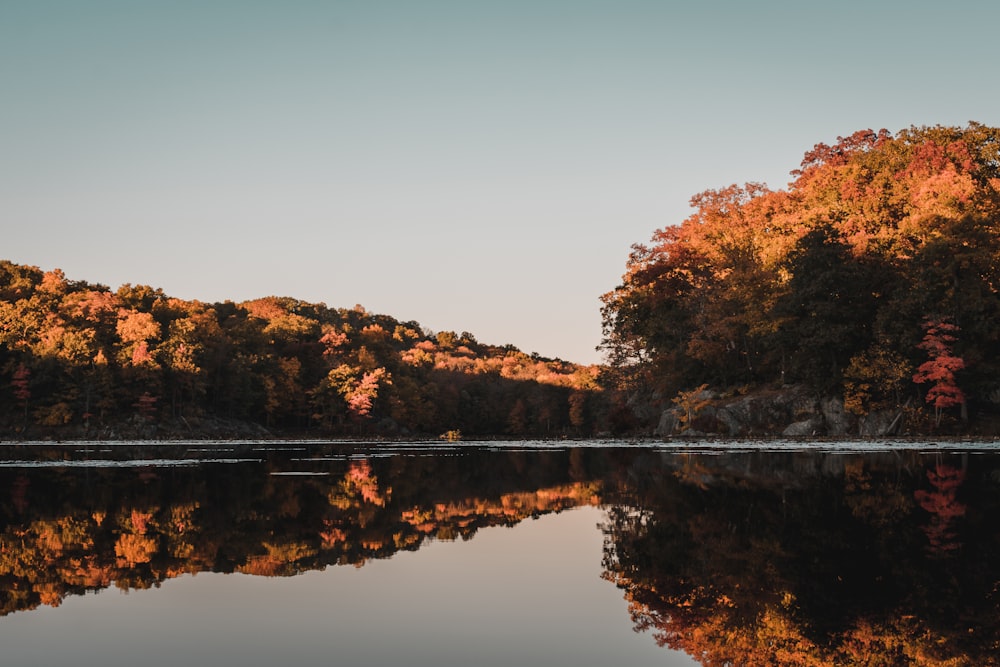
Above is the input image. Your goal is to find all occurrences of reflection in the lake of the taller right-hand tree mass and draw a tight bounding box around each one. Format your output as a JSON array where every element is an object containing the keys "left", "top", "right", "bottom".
[{"left": 604, "top": 453, "right": 1000, "bottom": 666}]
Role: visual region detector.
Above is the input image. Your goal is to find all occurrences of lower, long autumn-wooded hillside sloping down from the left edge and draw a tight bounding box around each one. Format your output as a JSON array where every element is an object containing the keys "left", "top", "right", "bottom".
[{"left": 0, "top": 261, "right": 608, "bottom": 438}]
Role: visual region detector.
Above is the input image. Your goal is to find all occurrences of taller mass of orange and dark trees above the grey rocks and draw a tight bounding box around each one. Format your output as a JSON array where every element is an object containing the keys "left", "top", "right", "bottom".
[{"left": 602, "top": 122, "right": 1000, "bottom": 430}]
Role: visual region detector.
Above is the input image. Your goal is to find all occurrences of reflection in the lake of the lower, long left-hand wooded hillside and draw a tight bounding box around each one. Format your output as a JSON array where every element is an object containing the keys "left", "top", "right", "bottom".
[{"left": 0, "top": 446, "right": 600, "bottom": 614}]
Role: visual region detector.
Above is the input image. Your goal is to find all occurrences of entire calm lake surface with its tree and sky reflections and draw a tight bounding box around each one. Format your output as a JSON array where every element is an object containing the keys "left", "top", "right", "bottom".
[{"left": 0, "top": 442, "right": 1000, "bottom": 666}]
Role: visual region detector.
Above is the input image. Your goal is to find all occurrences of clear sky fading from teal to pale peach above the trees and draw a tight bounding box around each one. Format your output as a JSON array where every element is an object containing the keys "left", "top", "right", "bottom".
[{"left": 0, "top": 0, "right": 1000, "bottom": 363}]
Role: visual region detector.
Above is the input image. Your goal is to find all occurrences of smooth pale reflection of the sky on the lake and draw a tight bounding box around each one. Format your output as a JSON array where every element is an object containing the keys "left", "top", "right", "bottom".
[{"left": 0, "top": 507, "right": 696, "bottom": 667}]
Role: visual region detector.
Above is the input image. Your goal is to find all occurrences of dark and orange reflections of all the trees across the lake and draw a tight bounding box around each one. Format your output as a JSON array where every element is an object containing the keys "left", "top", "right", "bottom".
[{"left": 0, "top": 444, "right": 1000, "bottom": 665}]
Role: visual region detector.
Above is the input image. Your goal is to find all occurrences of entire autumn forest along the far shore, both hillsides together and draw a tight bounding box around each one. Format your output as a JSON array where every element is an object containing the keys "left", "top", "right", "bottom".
[{"left": 11, "top": 122, "right": 1000, "bottom": 438}]
